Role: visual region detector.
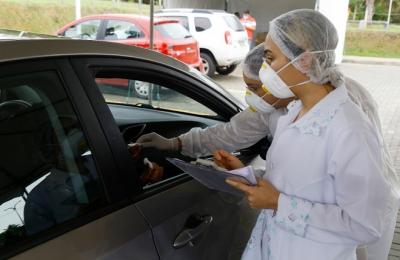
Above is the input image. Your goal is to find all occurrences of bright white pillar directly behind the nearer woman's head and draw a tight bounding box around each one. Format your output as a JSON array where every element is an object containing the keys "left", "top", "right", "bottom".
[{"left": 316, "top": 0, "right": 349, "bottom": 63}]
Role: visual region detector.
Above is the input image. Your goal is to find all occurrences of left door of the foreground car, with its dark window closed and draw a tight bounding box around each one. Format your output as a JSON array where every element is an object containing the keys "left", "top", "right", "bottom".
[{"left": 0, "top": 58, "right": 159, "bottom": 259}]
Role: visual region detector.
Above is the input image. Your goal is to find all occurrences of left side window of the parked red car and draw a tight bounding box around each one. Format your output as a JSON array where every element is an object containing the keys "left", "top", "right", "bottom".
[{"left": 64, "top": 20, "right": 101, "bottom": 40}]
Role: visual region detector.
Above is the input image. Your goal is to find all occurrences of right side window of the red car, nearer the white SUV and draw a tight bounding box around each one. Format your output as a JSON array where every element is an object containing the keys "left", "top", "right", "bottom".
[{"left": 104, "top": 20, "right": 144, "bottom": 40}]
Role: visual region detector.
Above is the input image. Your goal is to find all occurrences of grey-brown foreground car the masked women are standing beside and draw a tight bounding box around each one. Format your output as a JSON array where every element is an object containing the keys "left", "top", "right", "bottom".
[{"left": 0, "top": 39, "right": 266, "bottom": 260}]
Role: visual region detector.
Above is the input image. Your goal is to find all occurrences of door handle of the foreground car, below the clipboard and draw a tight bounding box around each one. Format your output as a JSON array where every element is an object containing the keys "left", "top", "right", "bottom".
[{"left": 172, "top": 215, "right": 213, "bottom": 249}]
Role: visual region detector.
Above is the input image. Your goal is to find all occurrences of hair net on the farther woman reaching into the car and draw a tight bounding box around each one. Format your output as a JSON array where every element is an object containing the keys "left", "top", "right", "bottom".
[{"left": 242, "top": 43, "right": 264, "bottom": 80}]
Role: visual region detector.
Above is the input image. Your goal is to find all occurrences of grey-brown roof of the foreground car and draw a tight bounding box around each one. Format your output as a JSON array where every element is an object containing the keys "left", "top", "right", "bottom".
[{"left": 0, "top": 38, "right": 190, "bottom": 72}]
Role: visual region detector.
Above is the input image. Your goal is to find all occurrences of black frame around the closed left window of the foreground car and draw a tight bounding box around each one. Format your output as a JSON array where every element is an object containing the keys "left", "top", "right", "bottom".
[{"left": 0, "top": 58, "right": 132, "bottom": 258}]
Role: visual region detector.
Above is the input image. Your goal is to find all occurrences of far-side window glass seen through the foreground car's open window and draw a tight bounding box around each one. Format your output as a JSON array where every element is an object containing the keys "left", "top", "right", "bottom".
[{"left": 96, "top": 78, "right": 217, "bottom": 116}]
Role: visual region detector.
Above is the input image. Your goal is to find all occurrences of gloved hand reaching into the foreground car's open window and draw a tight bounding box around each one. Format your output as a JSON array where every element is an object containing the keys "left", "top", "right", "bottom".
[{"left": 136, "top": 132, "right": 180, "bottom": 152}]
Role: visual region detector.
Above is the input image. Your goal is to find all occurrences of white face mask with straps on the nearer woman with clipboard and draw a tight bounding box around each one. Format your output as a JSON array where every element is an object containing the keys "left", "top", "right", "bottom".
[{"left": 259, "top": 50, "right": 334, "bottom": 98}]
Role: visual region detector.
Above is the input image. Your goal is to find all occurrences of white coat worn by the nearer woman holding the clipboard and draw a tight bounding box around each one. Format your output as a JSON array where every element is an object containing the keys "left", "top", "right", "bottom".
[{"left": 242, "top": 87, "right": 390, "bottom": 260}]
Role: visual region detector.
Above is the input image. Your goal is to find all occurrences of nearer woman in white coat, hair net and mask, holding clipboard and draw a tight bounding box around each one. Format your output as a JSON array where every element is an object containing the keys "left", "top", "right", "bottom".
[{"left": 215, "top": 10, "right": 392, "bottom": 260}]
